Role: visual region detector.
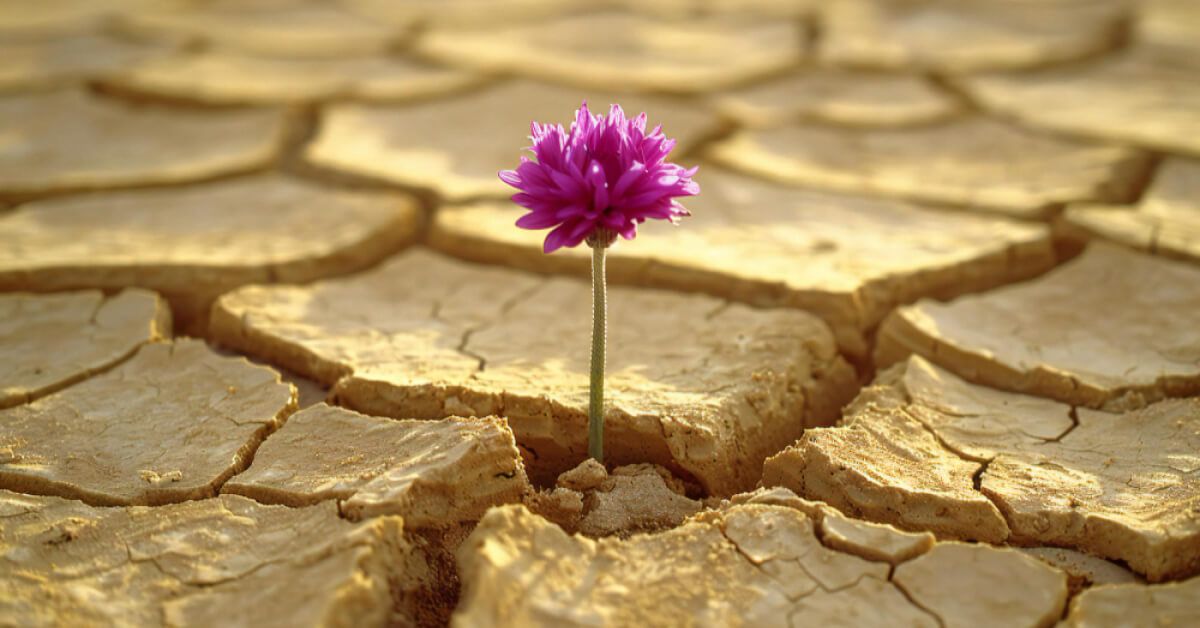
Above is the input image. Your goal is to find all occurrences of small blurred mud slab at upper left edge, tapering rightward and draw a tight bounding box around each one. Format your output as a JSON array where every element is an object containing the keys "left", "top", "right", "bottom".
[{"left": 0, "top": 34, "right": 174, "bottom": 91}]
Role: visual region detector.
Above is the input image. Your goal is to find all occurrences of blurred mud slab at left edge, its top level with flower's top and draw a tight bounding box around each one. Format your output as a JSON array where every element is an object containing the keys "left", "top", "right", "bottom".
[{"left": 0, "top": 90, "right": 284, "bottom": 196}]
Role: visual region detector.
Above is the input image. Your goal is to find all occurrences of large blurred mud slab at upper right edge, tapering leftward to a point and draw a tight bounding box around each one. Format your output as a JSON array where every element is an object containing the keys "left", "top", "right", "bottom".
[{"left": 959, "top": 47, "right": 1200, "bottom": 156}]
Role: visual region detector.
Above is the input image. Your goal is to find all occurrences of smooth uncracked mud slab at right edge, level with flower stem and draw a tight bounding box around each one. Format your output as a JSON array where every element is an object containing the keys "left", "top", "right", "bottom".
[{"left": 875, "top": 244, "right": 1200, "bottom": 411}]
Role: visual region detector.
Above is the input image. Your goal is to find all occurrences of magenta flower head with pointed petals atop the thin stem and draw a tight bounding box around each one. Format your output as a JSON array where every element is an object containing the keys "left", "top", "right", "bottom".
[{"left": 500, "top": 101, "right": 700, "bottom": 253}]
